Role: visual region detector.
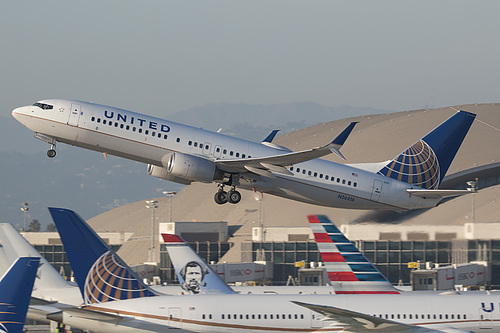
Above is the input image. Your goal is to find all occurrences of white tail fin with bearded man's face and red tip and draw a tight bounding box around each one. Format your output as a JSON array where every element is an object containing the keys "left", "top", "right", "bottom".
[{"left": 161, "top": 234, "right": 235, "bottom": 294}]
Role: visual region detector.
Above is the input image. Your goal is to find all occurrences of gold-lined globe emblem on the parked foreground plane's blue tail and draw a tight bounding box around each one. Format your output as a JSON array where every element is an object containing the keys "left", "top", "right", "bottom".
[{"left": 84, "top": 251, "right": 155, "bottom": 304}]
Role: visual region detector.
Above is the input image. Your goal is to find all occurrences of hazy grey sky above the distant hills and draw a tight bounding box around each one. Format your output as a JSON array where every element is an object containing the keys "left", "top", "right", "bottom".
[{"left": 0, "top": 0, "right": 500, "bottom": 116}]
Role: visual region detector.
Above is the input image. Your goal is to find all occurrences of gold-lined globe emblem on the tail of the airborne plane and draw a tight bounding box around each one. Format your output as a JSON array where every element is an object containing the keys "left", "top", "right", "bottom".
[{"left": 379, "top": 140, "right": 441, "bottom": 189}]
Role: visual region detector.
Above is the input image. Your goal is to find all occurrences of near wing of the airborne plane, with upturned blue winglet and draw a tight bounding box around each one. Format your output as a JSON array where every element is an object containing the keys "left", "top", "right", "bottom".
[{"left": 215, "top": 122, "right": 357, "bottom": 174}]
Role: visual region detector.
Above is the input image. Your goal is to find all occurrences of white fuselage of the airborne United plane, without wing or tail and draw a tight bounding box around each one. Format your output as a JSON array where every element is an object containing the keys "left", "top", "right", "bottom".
[{"left": 12, "top": 99, "right": 440, "bottom": 210}]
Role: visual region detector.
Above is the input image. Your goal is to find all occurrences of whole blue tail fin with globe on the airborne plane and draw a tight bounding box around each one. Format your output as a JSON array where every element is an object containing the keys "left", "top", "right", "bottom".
[{"left": 378, "top": 111, "right": 476, "bottom": 189}]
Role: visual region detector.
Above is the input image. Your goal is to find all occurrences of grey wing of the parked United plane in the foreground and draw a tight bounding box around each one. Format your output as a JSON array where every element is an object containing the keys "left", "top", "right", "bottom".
[{"left": 292, "top": 301, "right": 436, "bottom": 333}]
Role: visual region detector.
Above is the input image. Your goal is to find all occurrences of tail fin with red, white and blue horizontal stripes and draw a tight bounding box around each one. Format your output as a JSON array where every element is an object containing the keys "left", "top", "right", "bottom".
[{"left": 307, "top": 215, "right": 399, "bottom": 294}]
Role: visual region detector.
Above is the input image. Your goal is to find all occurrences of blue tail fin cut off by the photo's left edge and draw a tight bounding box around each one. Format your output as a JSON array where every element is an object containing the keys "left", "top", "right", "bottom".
[{"left": 0, "top": 257, "right": 40, "bottom": 333}]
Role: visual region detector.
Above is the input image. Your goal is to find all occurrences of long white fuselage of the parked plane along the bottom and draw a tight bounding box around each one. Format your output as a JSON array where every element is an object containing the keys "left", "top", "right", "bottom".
[{"left": 59, "top": 292, "right": 500, "bottom": 332}]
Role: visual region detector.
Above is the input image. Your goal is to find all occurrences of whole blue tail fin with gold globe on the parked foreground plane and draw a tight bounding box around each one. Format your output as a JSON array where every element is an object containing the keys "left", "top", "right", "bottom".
[{"left": 49, "top": 208, "right": 156, "bottom": 305}]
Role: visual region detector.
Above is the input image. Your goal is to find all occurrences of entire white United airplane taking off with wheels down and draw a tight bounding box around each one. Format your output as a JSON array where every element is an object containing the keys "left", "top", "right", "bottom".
[{"left": 12, "top": 99, "right": 475, "bottom": 210}]
